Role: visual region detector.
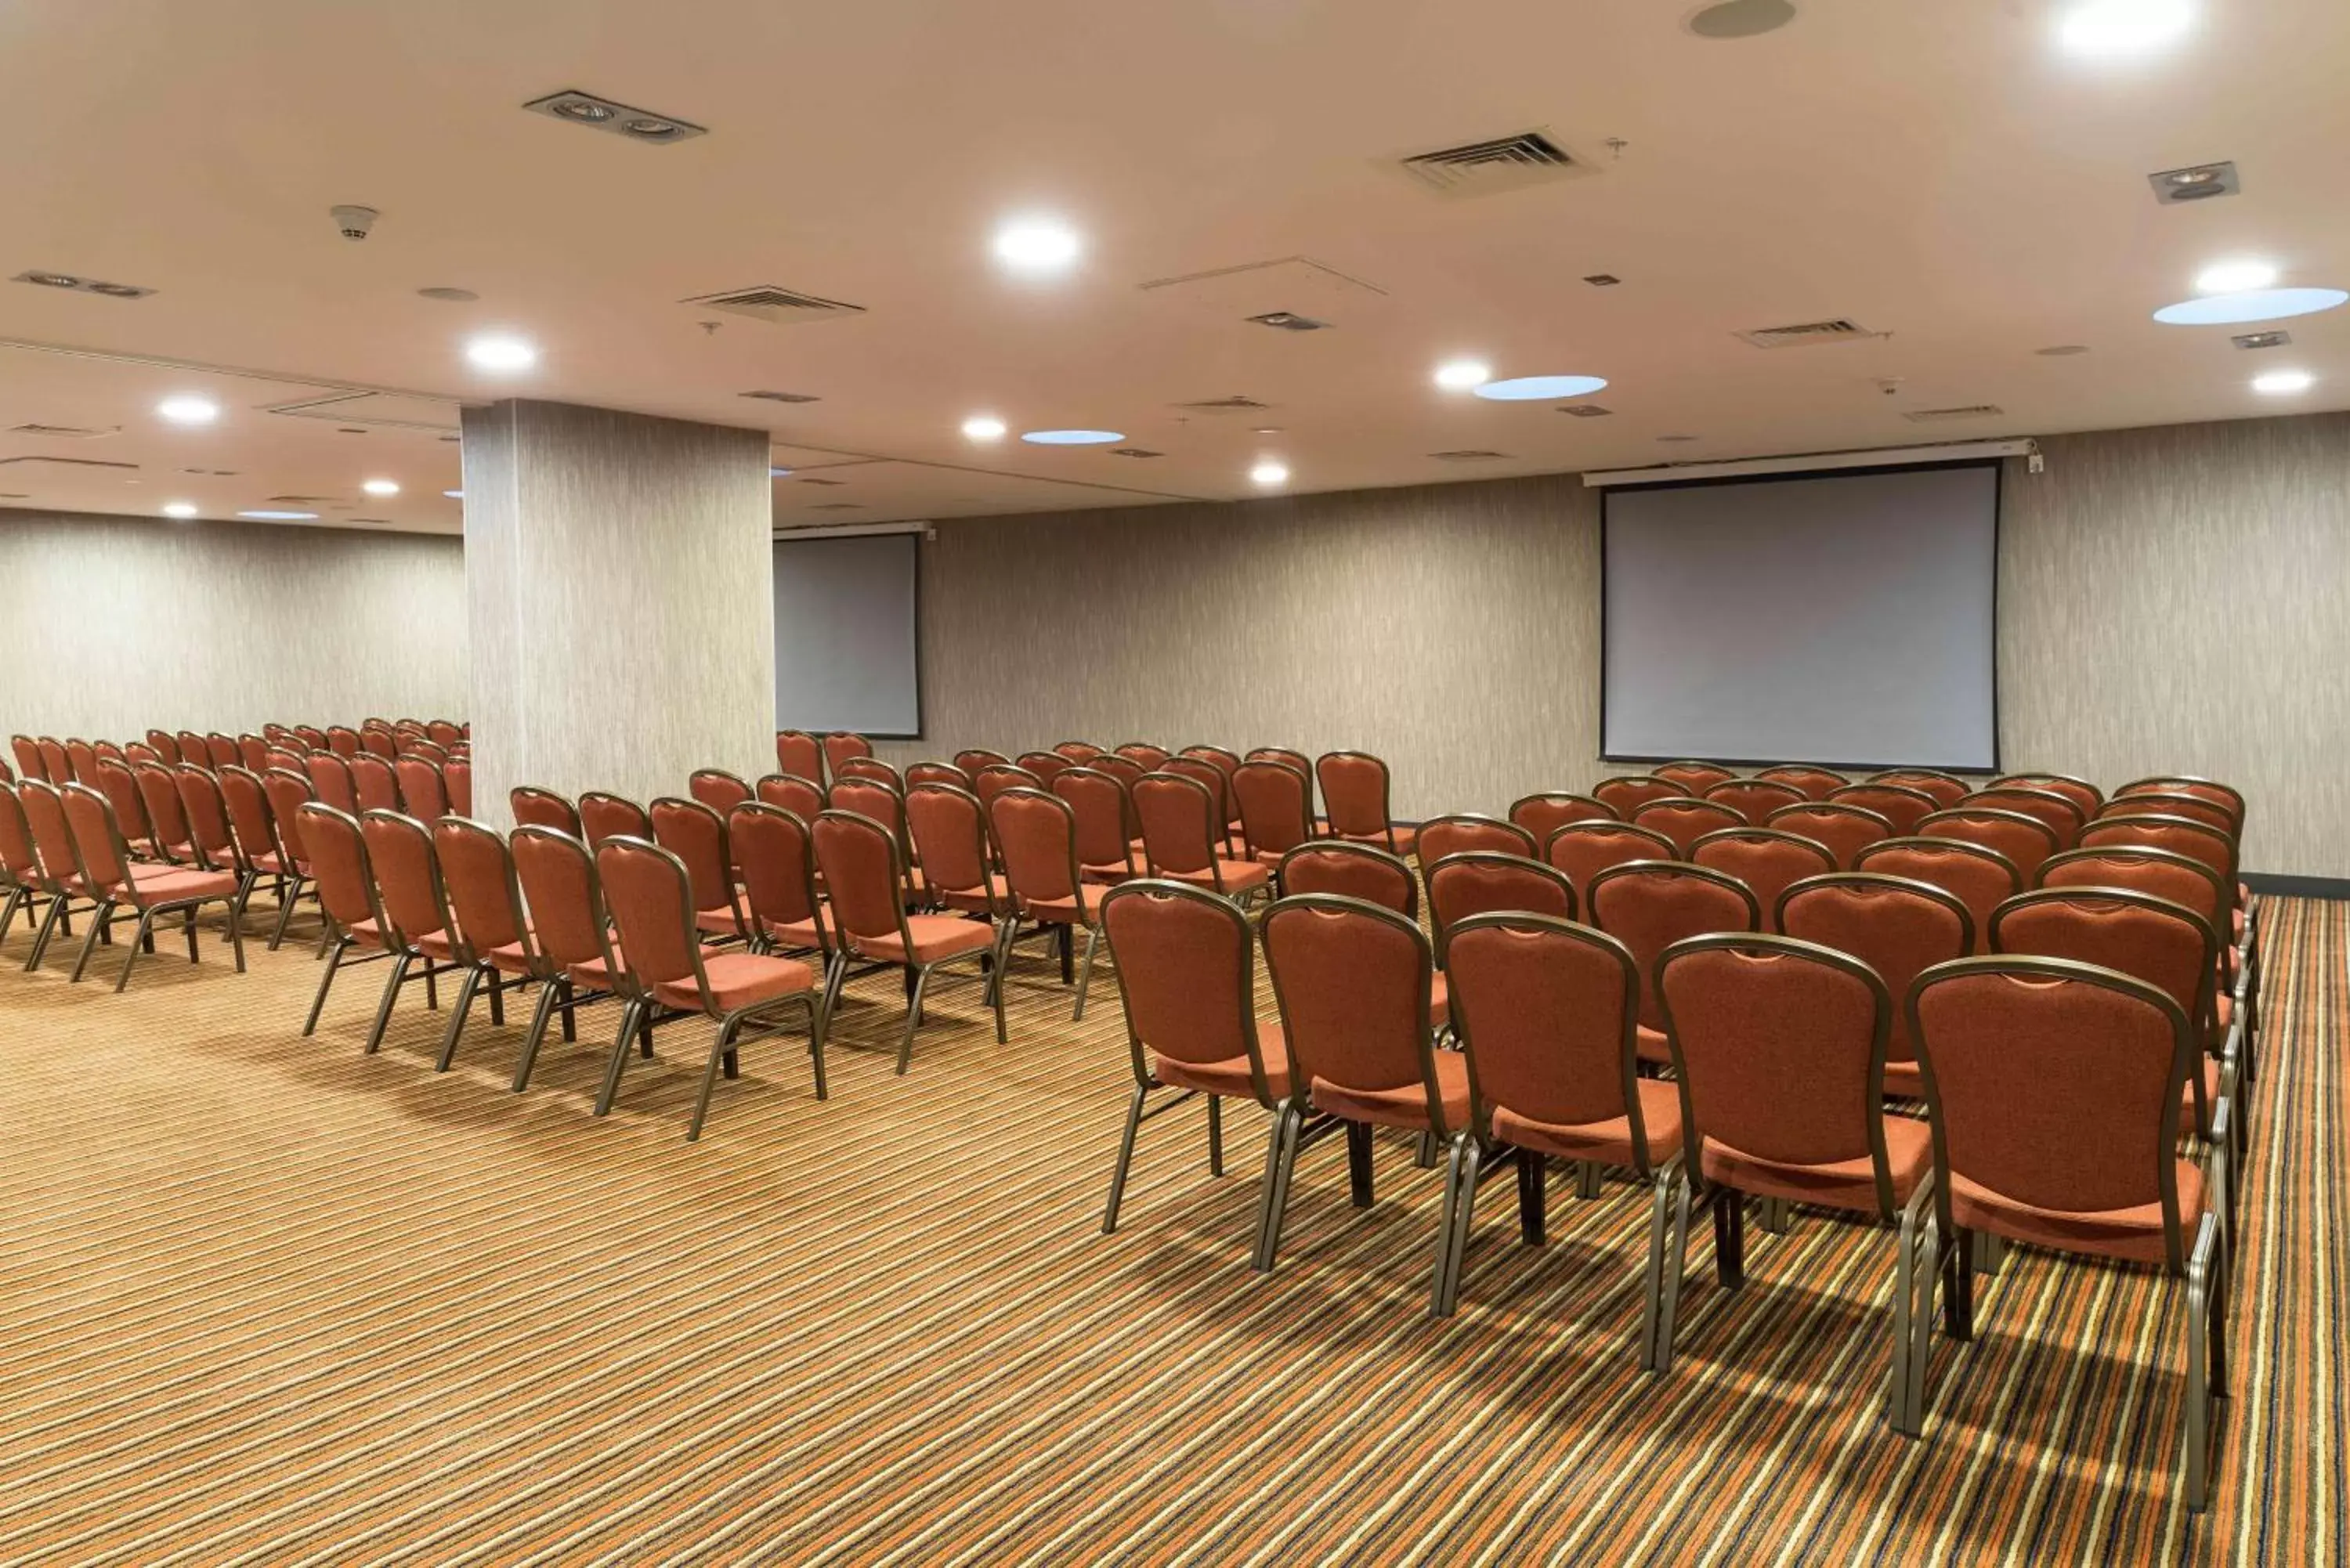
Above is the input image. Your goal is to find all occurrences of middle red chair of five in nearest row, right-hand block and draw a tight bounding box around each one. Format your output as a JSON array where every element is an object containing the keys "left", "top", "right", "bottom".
[{"left": 1429, "top": 912, "right": 1680, "bottom": 1317}]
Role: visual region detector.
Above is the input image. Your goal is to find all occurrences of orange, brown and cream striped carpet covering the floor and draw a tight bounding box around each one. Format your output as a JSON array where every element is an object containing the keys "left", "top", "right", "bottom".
[{"left": 0, "top": 901, "right": 2350, "bottom": 1568}]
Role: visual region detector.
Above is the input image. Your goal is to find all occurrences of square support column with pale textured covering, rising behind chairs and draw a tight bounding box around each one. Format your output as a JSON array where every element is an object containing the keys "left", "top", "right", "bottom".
[{"left": 465, "top": 399, "right": 776, "bottom": 826}]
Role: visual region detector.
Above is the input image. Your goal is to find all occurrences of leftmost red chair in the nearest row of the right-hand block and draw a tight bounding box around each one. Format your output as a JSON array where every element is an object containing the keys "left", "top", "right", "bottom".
[{"left": 1100, "top": 880, "right": 1297, "bottom": 1253}]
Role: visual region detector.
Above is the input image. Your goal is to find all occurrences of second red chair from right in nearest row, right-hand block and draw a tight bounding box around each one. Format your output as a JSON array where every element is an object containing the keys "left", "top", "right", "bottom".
[{"left": 1640, "top": 936, "right": 1934, "bottom": 1432}]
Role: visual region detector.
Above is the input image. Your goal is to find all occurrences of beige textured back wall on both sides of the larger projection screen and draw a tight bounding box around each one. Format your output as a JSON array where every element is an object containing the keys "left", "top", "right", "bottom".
[{"left": 886, "top": 414, "right": 2350, "bottom": 877}]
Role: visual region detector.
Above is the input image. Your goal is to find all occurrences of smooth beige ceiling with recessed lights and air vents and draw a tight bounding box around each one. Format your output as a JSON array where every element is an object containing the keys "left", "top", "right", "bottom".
[{"left": 0, "top": 0, "right": 2350, "bottom": 531}]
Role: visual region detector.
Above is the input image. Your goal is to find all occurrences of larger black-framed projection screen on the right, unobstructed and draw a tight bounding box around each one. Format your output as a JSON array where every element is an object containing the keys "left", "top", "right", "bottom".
[{"left": 1600, "top": 463, "right": 2000, "bottom": 768}]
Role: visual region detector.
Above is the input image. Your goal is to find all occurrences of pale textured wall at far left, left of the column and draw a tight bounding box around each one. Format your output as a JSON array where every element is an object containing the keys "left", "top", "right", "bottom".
[{"left": 0, "top": 512, "right": 468, "bottom": 738}]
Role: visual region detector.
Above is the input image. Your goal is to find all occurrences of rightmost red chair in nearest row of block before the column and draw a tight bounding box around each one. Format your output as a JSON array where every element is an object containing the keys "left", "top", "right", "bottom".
[{"left": 595, "top": 841, "right": 827, "bottom": 1143}]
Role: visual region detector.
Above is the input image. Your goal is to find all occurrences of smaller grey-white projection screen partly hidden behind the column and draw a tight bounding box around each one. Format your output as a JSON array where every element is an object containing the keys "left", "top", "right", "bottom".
[{"left": 776, "top": 533, "right": 921, "bottom": 740}]
